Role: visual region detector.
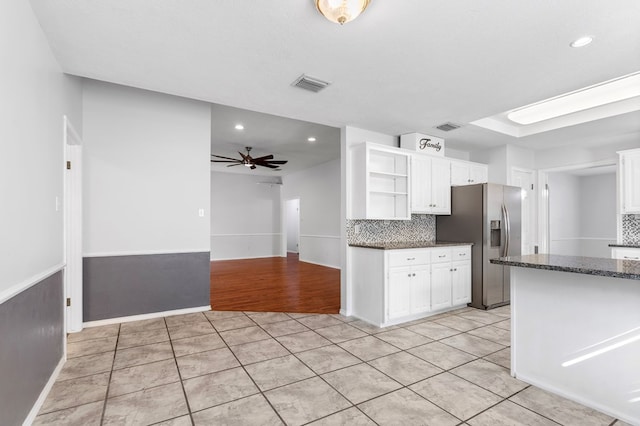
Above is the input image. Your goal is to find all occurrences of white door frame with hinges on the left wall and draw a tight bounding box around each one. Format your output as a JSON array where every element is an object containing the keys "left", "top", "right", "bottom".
[{"left": 63, "top": 115, "right": 83, "bottom": 333}]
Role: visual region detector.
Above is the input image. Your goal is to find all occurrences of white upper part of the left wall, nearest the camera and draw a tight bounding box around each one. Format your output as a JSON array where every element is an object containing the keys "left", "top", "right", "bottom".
[{"left": 0, "top": 0, "right": 82, "bottom": 303}]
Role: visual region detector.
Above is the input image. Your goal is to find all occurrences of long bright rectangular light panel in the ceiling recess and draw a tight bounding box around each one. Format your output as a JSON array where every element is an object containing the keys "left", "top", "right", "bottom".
[{"left": 507, "top": 73, "right": 640, "bottom": 125}]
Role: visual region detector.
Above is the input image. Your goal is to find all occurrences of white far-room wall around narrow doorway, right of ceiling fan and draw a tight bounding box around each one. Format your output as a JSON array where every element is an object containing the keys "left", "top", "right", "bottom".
[{"left": 282, "top": 159, "right": 341, "bottom": 268}]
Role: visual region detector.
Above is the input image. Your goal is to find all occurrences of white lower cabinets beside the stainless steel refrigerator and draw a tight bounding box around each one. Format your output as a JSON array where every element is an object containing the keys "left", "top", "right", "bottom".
[{"left": 349, "top": 246, "right": 471, "bottom": 327}]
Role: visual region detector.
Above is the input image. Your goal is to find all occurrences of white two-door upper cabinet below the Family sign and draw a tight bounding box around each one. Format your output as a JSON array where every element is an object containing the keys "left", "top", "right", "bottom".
[{"left": 411, "top": 154, "right": 451, "bottom": 214}]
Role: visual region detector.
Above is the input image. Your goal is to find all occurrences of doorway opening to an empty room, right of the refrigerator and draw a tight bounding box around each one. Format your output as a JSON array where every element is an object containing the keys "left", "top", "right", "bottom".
[{"left": 539, "top": 160, "right": 619, "bottom": 258}]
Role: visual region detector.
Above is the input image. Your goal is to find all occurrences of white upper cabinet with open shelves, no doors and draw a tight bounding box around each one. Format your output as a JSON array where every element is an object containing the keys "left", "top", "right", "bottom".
[{"left": 350, "top": 142, "right": 411, "bottom": 220}]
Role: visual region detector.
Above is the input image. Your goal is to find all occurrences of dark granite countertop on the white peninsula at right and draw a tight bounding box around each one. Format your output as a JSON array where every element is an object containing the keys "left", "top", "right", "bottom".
[{"left": 490, "top": 254, "right": 640, "bottom": 280}]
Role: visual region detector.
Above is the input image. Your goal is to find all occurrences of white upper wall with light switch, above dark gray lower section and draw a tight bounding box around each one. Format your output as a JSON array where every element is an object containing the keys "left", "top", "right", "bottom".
[{"left": 83, "top": 80, "right": 211, "bottom": 256}]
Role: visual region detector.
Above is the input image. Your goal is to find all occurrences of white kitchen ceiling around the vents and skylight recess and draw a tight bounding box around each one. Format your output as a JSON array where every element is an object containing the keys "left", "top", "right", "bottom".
[{"left": 31, "top": 0, "right": 640, "bottom": 157}]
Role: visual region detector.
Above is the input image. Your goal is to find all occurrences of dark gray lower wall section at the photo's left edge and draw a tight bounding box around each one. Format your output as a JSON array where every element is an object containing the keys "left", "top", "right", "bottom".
[{"left": 0, "top": 272, "right": 64, "bottom": 425}]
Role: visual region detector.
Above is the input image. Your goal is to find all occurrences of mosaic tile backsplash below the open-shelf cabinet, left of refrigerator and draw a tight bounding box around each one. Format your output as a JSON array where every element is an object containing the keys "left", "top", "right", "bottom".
[{"left": 347, "top": 214, "right": 436, "bottom": 244}]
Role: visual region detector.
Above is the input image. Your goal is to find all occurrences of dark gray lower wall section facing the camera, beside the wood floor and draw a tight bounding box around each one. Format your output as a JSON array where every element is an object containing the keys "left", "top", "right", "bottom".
[{"left": 83, "top": 252, "right": 210, "bottom": 321}]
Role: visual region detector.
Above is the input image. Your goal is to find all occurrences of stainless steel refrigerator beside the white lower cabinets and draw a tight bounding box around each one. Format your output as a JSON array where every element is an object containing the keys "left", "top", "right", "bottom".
[{"left": 436, "top": 183, "right": 522, "bottom": 309}]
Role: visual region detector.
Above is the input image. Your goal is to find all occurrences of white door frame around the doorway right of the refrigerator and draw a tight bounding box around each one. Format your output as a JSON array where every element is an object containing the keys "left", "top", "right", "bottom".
[{"left": 537, "top": 158, "right": 622, "bottom": 253}]
